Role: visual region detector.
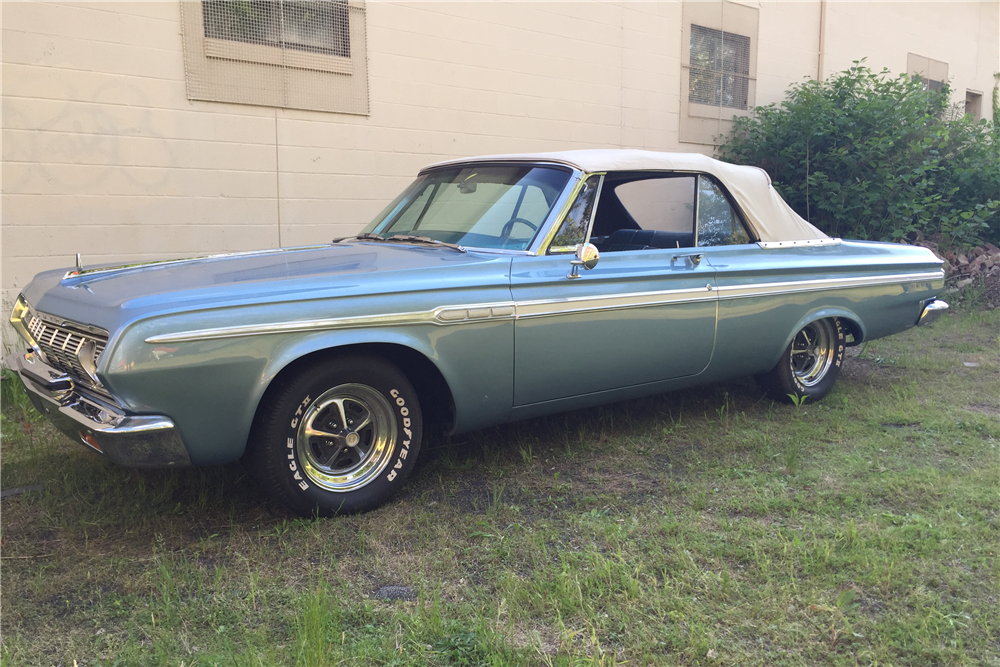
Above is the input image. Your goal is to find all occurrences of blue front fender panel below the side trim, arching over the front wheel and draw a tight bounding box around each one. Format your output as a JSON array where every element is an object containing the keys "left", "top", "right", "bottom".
[{"left": 103, "top": 321, "right": 514, "bottom": 465}]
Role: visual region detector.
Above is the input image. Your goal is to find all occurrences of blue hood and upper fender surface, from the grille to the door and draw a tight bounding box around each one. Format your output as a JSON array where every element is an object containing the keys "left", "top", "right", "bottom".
[{"left": 23, "top": 242, "right": 510, "bottom": 332}]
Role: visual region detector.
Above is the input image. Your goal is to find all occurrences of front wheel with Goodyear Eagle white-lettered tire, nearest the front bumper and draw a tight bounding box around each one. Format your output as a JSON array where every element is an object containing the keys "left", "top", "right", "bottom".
[{"left": 248, "top": 356, "right": 422, "bottom": 516}]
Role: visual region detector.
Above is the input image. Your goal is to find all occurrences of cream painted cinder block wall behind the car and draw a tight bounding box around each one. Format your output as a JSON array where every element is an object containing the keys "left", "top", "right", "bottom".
[{"left": 0, "top": 0, "right": 1000, "bottom": 352}]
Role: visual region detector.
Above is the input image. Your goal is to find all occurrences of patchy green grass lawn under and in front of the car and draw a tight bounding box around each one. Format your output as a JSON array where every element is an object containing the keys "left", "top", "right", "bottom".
[{"left": 0, "top": 310, "right": 1000, "bottom": 667}]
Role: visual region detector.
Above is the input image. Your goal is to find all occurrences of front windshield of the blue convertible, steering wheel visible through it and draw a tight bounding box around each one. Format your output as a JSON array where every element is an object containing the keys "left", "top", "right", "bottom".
[{"left": 364, "top": 165, "right": 571, "bottom": 250}]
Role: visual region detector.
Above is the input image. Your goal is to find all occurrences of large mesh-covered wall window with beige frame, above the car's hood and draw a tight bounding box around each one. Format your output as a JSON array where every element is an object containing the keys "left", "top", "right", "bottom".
[{"left": 181, "top": 0, "right": 368, "bottom": 115}]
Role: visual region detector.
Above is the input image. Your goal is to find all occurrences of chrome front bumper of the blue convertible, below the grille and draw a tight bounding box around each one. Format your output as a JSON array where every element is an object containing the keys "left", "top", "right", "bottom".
[{"left": 5, "top": 352, "right": 191, "bottom": 468}]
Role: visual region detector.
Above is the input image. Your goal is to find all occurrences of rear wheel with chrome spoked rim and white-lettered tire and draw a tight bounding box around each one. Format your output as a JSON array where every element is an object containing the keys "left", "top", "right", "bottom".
[{"left": 756, "top": 317, "right": 844, "bottom": 403}]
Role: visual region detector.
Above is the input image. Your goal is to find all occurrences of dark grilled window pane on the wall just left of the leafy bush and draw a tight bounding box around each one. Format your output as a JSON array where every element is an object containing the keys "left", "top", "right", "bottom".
[{"left": 688, "top": 24, "right": 750, "bottom": 110}]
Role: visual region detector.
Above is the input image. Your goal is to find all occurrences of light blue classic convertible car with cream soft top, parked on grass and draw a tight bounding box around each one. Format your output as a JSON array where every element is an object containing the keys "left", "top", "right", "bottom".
[{"left": 7, "top": 150, "right": 948, "bottom": 515}]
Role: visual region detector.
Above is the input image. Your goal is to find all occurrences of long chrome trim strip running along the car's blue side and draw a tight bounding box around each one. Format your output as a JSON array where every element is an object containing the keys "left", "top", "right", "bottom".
[{"left": 146, "top": 270, "right": 944, "bottom": 345}]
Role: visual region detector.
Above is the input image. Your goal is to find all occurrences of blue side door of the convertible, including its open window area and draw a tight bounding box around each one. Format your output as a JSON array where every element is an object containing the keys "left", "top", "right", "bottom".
[{"left": 511, "top": 174, "right": 717, "bottom": 407}]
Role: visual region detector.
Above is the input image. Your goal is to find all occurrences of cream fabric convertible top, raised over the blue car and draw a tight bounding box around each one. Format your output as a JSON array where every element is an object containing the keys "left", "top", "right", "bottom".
[{"left": 421, "top": 149, "right": 829, "bottom": 242}]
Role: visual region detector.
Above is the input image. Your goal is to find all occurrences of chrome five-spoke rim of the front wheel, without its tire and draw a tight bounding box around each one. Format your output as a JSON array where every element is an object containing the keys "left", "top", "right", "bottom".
[{"left": 296, "top": 384, "right": 397, "bottom": 493}]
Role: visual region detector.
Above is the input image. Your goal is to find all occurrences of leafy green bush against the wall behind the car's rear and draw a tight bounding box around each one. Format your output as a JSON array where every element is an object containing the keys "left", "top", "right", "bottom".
[{"left": 719, "top": 61, "right": 1000, "bottom": 246}]
